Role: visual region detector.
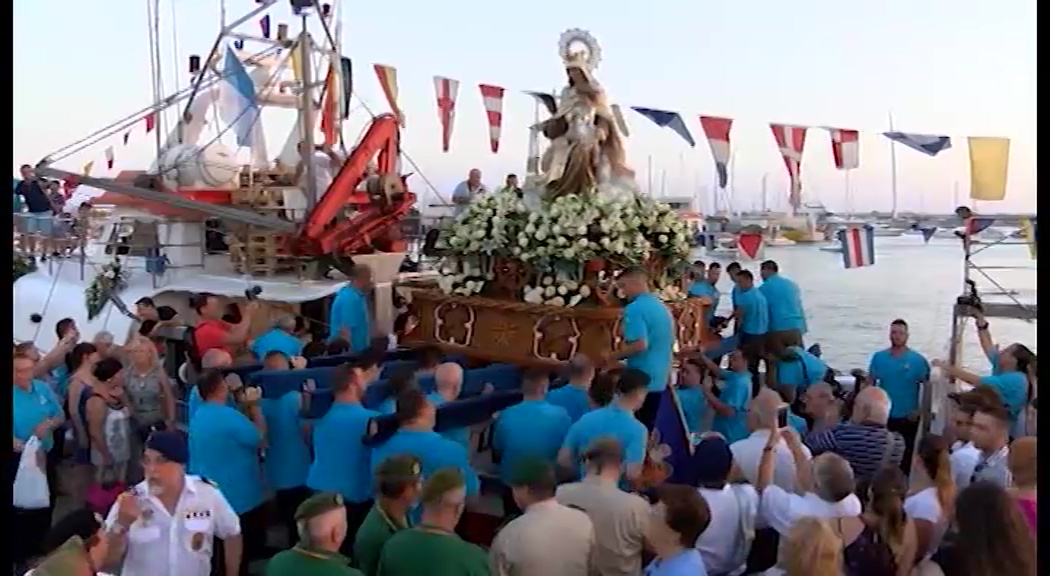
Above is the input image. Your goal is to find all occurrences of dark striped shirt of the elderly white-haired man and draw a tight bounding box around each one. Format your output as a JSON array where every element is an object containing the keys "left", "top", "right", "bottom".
[{"left": 805, "top": 422, "right": 904, "bottom": 483}]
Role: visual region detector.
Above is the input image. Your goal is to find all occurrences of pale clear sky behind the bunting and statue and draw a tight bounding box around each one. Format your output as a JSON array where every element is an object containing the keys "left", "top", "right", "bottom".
[{"left": 13, "top": 0, "right": 1036, "bottom": 212}]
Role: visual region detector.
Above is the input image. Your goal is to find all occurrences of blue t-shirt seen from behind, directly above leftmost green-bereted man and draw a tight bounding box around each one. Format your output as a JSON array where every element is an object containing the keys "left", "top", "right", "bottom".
[{"left": 307, "top": 402, "right": 379, "bottom": 503}]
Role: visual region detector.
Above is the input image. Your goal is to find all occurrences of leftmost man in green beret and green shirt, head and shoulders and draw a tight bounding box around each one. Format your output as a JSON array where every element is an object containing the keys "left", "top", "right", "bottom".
[{"left": 266, "top": 492, "right": 362, "bottom": 576}]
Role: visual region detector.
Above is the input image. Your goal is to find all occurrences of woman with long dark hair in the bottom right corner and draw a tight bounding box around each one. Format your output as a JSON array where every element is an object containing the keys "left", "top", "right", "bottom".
[{"left": 932, "top": 482, "right": 1036, "bottom": 576}]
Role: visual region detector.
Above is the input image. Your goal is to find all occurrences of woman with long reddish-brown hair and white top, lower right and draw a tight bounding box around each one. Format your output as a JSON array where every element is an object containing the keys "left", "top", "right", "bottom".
[{"left": 904, "top": 434, "right": 956, "bottom": 560}]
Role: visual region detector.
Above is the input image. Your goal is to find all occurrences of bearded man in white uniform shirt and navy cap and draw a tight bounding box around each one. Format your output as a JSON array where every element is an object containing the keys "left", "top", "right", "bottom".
[{"left": 106, "top": 430, "right": 241, "bottom": 576}]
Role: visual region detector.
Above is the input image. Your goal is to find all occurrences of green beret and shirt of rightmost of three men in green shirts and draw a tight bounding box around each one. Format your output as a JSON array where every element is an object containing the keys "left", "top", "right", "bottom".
[{"left": 375, "top": 468, "right": 491, "bottom": 576}]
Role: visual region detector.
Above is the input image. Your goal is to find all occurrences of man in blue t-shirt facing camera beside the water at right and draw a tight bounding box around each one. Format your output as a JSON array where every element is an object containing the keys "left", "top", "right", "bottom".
[{"left": 867, "top": 318, "right": 929, "bottom": 474}]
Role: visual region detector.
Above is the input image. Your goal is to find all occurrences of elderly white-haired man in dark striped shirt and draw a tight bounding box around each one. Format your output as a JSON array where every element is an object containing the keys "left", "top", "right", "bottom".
[{"left": 805, "top": 386, "right": 904, "bottom": 485}]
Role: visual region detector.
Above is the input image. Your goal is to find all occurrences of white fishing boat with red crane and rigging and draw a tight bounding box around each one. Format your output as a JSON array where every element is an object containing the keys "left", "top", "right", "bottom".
[{"left": 13, "top": 0, "right": 416, "bottom": 349}]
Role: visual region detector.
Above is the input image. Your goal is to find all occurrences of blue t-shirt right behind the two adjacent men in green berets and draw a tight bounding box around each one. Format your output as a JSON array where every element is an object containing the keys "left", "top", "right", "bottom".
[{"left": 371, "top": 429, "right": 479, "bottom": 496}]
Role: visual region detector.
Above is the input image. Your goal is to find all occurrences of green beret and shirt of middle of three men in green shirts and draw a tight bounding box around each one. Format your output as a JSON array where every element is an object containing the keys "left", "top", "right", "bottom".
[{"left": 354, "top": 454, "right": 422, "bottom": 576}]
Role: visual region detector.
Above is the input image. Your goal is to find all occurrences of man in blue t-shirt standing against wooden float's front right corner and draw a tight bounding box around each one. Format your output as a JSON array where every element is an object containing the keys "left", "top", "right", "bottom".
[{"left": 608, "top": 268, "right": 675, "bottom": 429}]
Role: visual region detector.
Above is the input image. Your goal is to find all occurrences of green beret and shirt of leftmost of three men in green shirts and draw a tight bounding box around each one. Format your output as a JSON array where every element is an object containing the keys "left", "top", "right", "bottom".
[{"left": 266, "top": 492, "right": 363, "bottom": 576}]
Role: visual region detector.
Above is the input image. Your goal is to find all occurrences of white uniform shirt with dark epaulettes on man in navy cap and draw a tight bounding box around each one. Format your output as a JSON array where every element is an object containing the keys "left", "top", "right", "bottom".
[{"left": 106, "top": 475, "right": 240, "bottom": 576}]
